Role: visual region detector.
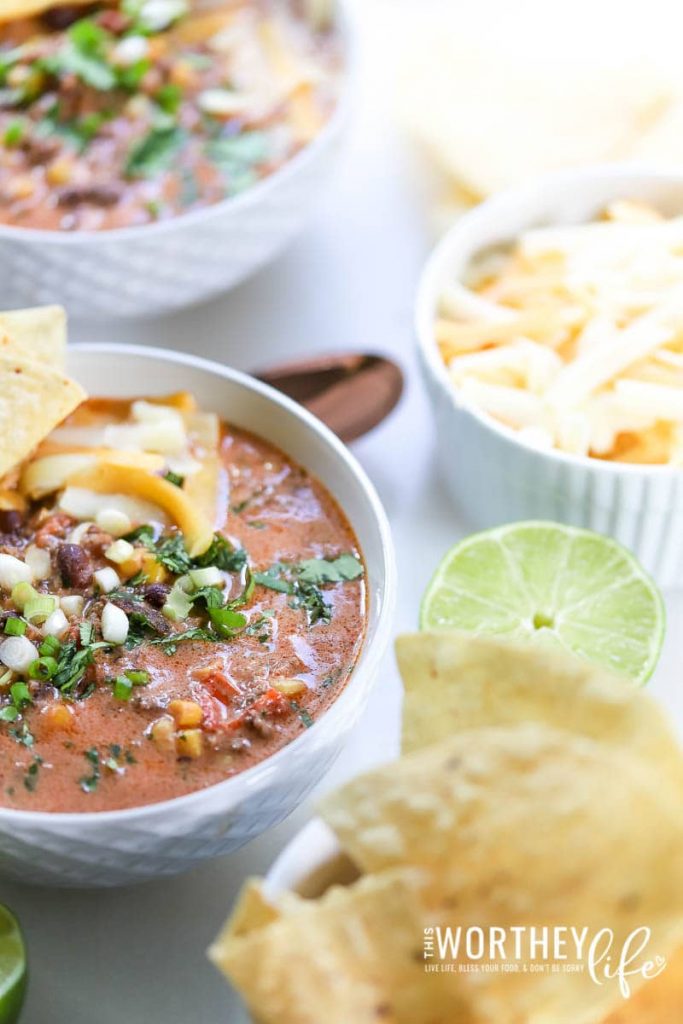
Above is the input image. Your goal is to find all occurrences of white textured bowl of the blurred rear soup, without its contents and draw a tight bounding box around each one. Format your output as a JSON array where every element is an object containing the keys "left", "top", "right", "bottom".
[{"left": 0, "top": 0, "right": 355, "bottom": 316}]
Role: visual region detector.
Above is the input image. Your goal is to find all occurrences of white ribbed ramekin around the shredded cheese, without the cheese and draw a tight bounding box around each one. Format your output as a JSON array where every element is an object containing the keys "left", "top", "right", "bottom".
[{"left": 417, "top": 165, "right": 683, "bottom": 588}]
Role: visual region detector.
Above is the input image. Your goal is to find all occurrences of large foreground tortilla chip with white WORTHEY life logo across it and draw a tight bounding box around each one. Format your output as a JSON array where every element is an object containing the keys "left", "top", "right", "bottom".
[{"left": 321, "top": 724, "right": 683, "bottom": 1024}]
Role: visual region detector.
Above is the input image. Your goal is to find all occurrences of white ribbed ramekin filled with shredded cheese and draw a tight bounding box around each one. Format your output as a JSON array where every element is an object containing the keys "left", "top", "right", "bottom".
[{"left": 417, "top": 167, "right": 683, "bottom": 587}]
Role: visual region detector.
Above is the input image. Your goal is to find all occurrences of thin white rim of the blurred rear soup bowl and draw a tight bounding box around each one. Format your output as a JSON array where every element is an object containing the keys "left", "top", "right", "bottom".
[{"left": 0, "top": 0, "right": 358, "bottom": 246}]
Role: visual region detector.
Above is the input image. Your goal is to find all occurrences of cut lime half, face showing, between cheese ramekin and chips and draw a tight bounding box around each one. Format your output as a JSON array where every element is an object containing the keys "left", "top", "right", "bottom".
[{"left": 420, "top": 522, "right": 665, "bottom": 683}]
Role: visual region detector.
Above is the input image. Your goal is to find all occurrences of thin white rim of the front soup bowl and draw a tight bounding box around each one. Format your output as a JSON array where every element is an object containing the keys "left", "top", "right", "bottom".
[{"left": 0, "top": 342, "right": 396, "bottom": 827}]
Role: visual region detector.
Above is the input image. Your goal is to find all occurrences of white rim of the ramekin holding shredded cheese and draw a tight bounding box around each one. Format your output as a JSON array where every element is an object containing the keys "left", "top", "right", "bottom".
[{"left": 415, "top": 161, "right": 683, "bottom": 479}]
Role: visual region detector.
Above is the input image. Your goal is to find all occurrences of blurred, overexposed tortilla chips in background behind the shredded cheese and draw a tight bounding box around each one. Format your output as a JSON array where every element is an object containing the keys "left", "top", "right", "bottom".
[{"left": 389, "top": 12, "right": 680, "bottom": 199}]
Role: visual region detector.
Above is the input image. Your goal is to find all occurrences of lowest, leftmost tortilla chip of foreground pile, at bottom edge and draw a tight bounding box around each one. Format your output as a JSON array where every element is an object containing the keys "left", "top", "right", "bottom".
[{"left": 209, "top": 870, "right": 462, "bottom": 1024}]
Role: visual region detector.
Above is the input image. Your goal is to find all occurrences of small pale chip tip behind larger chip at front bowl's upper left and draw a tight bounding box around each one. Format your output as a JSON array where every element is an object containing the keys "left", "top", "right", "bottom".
[{"left": 0, "top": 306, "right": 67, "bottom": 373}]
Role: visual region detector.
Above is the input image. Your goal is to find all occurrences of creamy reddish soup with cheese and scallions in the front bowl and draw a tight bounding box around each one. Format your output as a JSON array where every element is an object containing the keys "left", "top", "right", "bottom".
[{"left": 0, "top": 394, "right": 367, "bottom": 811}]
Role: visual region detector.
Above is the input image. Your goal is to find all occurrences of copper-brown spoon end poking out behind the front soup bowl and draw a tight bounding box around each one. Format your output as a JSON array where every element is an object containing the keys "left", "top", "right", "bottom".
[{"left": 255, "top": 352, "right": 403, "bottom": 444}]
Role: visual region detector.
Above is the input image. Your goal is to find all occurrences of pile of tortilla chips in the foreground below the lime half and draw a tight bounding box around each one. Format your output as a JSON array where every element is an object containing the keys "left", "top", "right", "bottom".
[{"left": 211, "top": 634, "right": 683, "bottom": 1024}]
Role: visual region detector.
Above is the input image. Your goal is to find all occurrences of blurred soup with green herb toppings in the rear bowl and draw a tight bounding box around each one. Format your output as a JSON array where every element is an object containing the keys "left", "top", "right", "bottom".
[{"left": 0, "top": 0, "right": 340, "bottom": 230}]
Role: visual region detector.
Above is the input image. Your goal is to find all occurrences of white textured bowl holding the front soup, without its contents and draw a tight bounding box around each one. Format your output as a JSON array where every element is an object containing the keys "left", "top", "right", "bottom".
[{"left": 0, "top": 345, "right": 396, "bottom": 886}]
